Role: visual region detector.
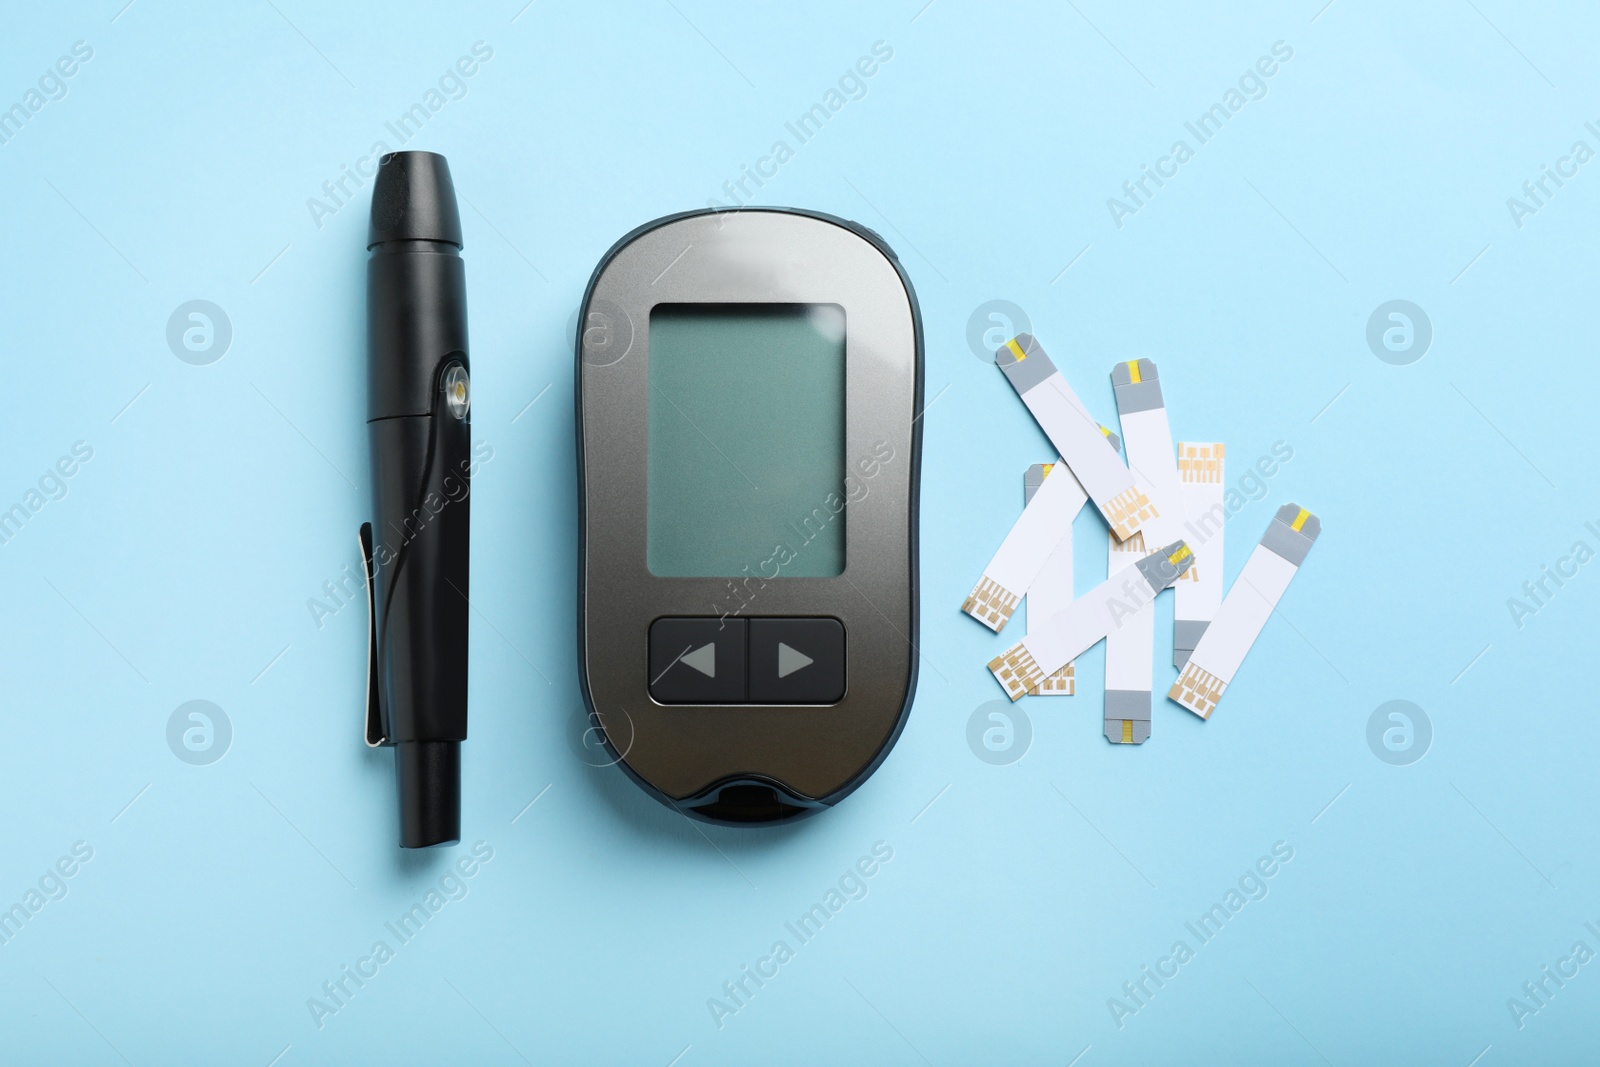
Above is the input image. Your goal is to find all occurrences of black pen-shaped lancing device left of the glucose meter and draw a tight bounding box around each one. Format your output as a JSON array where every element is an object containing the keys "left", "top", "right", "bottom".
[{"left": 366, "top": 152, "right": 472, "bottom": 848}]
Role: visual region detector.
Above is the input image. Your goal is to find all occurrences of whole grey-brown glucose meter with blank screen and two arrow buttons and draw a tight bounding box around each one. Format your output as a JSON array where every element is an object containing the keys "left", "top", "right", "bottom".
[{"left": 576, "top": 210, "right": 923, "bottom": 824}]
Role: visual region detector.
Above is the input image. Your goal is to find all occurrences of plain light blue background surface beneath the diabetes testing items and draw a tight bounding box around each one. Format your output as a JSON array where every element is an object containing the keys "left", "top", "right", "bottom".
[{"left": 0, "top": 0, "right": 1600, "bottom": 1067}]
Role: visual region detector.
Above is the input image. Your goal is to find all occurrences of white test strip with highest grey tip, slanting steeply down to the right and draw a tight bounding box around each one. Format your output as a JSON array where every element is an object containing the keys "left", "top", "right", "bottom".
[{"left": 995, "top": 333, "right": 1157, "bottom": 541}]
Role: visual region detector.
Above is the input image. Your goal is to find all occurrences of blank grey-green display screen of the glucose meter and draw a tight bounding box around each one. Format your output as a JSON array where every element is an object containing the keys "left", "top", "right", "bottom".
[{"left": 646, "top": 304, "right": 845, "bottom": 579}]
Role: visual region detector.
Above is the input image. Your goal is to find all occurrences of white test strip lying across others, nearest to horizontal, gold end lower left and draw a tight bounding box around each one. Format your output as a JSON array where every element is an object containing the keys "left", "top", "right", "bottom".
[{"left": 989, "top": 541, "right": 1194, "bottom": 701}]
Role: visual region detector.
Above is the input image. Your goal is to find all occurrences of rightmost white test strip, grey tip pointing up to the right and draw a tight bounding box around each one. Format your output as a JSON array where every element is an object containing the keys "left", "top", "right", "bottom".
[{"left": 1166, "top": 504, "right": 1322, "bottom": 718}]
